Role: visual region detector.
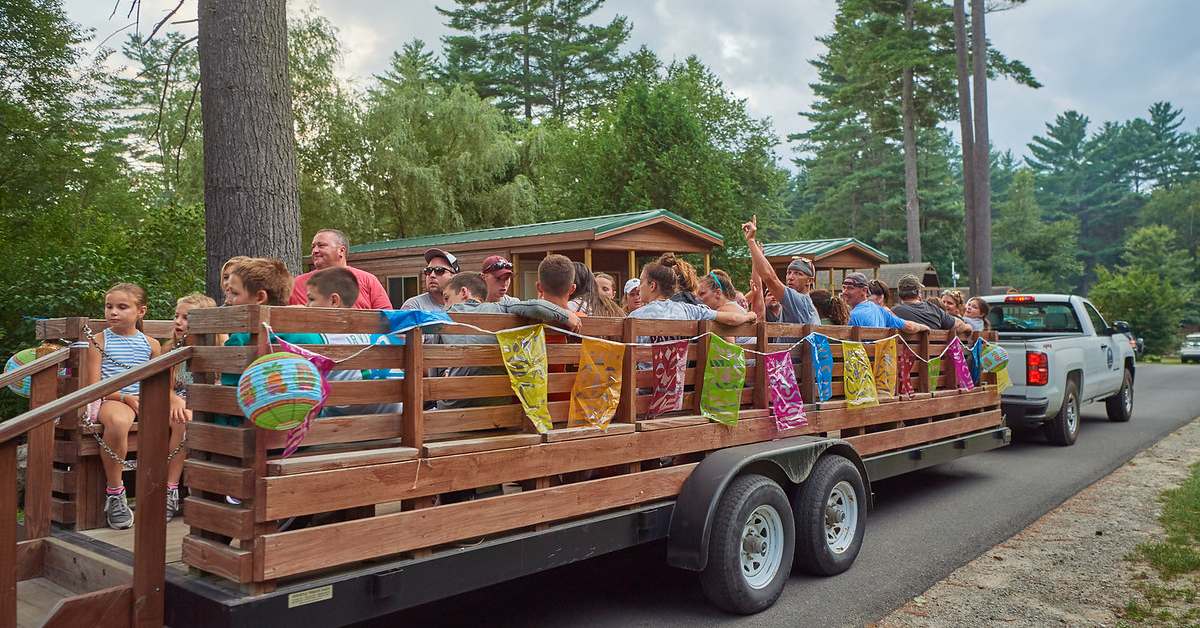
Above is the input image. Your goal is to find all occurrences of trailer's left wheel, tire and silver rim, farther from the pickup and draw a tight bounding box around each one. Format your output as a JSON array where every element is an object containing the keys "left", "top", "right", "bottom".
[{"left": 700, "top": 473, "right": 796, "bottom": 615}]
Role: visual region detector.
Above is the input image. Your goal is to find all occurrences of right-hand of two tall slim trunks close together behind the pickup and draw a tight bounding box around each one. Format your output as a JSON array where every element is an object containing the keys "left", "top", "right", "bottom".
[{"left": 971, "top": 0, "right": 991, "bottom": 295}]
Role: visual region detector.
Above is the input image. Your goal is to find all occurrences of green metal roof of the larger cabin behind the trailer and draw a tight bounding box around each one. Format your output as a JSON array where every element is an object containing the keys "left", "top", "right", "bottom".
[{"left": 350, "top": 209, "right": 725, "bottom": 253}]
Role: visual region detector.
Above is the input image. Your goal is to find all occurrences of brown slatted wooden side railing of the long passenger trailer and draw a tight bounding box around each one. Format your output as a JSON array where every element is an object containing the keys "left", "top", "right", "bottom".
[{"left": 182, "top": 306, "right": 1001, "bottom": 593}]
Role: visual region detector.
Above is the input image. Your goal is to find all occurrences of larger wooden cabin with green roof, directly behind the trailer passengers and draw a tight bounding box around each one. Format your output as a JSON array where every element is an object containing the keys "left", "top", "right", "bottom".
[{"left": 348, "top": 209, "right": 724, "bottom": 307}]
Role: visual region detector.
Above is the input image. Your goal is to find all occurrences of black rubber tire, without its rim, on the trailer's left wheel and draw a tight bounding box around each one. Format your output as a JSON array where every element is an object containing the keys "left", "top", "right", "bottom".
[{"left": 700, "top": 473, "right": 796, "bottom": 615}]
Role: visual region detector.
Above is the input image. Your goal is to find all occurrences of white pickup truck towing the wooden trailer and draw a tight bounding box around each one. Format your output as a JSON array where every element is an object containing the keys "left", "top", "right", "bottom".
[{"left": 984, "top": 294, "right": 1135, "bottom": 445}]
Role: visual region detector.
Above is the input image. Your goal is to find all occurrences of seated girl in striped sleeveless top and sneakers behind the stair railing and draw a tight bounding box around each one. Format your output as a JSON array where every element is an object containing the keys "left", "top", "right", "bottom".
[{"left": 86, "top": 283, "right": 163, "bottom": 530}]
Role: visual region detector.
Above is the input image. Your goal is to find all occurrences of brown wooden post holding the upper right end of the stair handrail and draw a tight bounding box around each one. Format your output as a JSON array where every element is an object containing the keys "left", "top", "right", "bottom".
[{"left": 133, "top": 369, "right": 172, "bottom": 628}]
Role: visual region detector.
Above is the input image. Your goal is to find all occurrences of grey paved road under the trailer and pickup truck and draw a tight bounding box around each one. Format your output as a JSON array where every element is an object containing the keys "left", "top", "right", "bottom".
[{"left": 376, "top": 365, "right": 1200, "bottom": 627}]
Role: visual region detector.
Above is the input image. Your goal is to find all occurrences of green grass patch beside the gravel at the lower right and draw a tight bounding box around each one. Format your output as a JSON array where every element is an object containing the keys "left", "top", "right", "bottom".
[{"left": 1122, "top": 463, "right": 1200, "bottom": 626}]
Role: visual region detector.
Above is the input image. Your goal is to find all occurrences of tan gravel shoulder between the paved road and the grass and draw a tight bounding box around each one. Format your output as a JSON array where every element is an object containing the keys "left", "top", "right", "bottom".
[{"left": 876, "top": 418, "right": 1200, "bottom": 628}]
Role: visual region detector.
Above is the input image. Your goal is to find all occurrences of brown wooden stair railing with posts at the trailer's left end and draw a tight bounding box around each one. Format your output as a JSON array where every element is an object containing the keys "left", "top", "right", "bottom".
[{"left": 0, "top": 347, "right": 192, "bottom": 627}]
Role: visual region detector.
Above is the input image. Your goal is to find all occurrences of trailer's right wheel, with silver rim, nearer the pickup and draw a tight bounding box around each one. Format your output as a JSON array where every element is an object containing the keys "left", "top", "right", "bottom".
[{"left": 793, "top": 455, "right": 866, "bottom": 575}]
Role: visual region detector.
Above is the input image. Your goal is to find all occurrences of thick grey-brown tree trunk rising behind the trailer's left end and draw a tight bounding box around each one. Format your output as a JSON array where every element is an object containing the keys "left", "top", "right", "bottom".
[{"left": 198, "top": 0, "right": 300, "bottom": 295}]
